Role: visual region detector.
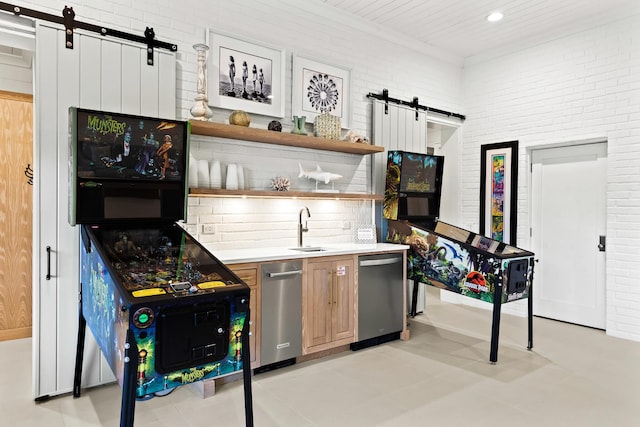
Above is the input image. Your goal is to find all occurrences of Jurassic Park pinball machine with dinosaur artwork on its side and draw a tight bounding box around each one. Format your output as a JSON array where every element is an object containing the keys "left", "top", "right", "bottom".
[{"left": 383, "top": 151, "right": 535, "bottom": 363}]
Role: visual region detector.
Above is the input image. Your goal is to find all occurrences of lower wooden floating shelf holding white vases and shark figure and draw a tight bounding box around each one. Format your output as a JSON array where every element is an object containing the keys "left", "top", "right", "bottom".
[{"left": 189, "top": 188, "right": 383, "bottom": 200}]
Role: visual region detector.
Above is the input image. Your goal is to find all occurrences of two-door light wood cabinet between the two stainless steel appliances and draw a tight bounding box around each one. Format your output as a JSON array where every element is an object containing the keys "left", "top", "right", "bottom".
[{"left": 302, "top": 256, "right": 357, "bottom": 354}]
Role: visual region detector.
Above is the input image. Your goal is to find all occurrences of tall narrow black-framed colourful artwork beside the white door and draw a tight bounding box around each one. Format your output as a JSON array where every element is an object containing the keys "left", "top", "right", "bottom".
[{"left": 480, "top": 141, "right": 518, "bottom": 246}]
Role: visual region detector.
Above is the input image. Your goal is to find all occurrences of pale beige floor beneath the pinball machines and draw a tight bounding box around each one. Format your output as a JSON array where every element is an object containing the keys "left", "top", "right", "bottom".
[{"left": 0, "top": 292, "right": 640, "bottom": 427}]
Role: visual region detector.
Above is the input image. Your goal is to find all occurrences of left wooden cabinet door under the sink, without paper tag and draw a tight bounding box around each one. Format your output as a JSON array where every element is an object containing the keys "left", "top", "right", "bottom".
[{"left": 304, "top": 262, "right": 333, "bottom": 347}]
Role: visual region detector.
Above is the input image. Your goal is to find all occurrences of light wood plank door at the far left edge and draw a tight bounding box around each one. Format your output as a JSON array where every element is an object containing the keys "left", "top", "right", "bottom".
[{"left": 0, "top": 91, "right": 33, "bottom": 341}]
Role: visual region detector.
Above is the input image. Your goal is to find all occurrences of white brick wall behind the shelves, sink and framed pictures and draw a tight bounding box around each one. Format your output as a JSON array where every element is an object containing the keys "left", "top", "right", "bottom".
[{"left": 20, "top": 0, "right": 462, "bottom": 250}]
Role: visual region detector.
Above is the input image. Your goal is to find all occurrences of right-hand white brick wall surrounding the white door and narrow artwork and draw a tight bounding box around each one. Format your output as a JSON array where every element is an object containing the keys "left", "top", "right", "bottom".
[{"left": 461, "top": 15, "right": 640, "bottom": 341}]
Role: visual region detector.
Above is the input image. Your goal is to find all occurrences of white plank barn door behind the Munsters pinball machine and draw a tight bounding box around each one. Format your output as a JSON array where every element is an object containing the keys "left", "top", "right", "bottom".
[{"left": 33, "top": 24, "right": 176, "bottom": 398}]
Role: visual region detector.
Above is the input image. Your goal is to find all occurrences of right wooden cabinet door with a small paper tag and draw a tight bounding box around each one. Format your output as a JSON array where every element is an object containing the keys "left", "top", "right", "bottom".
[{"left": 331, "top": 258, "right": 355, "bottom": 341}]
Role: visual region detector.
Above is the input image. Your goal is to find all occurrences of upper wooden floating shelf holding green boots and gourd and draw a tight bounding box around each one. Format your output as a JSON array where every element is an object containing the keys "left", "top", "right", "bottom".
[{"left": 190, "top": 120, "right": 384, "bottom": 154}]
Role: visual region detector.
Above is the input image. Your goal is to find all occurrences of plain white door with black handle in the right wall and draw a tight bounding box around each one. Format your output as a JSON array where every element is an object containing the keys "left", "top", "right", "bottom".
[{"left": 531, "top": 143, "right": 607, "bottom": 329}]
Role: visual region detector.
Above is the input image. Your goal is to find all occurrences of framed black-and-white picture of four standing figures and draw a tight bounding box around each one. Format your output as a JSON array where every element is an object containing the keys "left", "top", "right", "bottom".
[{"left": 206, "top": 30, "right": 285, "bottom": 117}]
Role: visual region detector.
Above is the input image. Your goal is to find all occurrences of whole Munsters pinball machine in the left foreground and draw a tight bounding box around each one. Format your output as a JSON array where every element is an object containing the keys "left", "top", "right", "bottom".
[{"left": 69, "top": 108, "right": 253, "bottom": 426}]
